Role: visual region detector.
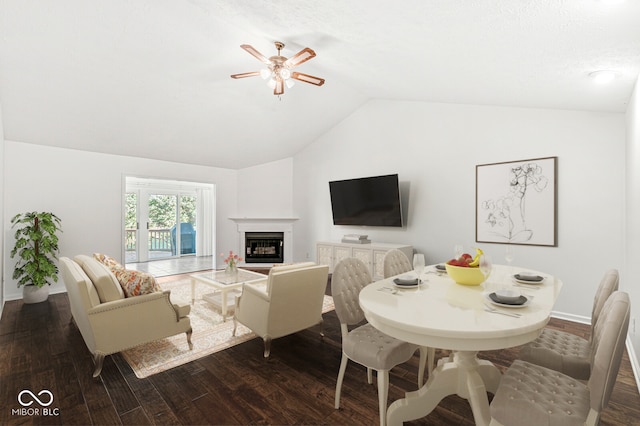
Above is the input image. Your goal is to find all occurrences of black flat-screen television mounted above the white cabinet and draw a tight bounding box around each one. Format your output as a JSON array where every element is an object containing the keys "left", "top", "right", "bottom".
[{"left": 329, "top": 174, "right": 402, "bottom": 227}]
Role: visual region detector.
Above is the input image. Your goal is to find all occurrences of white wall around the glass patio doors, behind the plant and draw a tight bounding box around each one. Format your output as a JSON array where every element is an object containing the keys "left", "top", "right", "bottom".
[{"left": 2, "top": 141, "right": 238, "bottom": 300}]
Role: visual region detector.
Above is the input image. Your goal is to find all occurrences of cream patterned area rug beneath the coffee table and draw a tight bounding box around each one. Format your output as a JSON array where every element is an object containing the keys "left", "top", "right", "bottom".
[{"left": 122, "top": 278, "right": 334, "bottom": 379}]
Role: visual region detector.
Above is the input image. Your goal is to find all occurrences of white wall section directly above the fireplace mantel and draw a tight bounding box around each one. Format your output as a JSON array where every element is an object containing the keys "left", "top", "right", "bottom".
[{"left": 235, "top": 158, "right": 293, "bottom": 218}]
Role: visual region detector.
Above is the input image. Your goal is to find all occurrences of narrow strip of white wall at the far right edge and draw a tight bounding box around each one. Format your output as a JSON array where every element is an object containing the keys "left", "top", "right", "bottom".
[{"left": 620, "top": 75, "right": 640, "bottom": 360}]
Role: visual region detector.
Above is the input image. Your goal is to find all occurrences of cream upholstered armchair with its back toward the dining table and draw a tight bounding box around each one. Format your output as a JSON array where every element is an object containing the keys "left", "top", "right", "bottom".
[{"left": 233, "top": 262, "right": 329, "bottom": 358}]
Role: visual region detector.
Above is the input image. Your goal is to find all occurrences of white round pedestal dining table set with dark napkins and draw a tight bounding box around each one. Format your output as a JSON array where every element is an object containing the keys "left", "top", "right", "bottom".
[{"left": 360, "top": 265, "right": 562, "bottom": 426}]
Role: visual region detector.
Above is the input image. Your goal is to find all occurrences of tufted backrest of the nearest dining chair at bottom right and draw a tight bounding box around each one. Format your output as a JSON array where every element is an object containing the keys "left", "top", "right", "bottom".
[{"left": 589, "top": 291, "right": 631, "bottom": 413}]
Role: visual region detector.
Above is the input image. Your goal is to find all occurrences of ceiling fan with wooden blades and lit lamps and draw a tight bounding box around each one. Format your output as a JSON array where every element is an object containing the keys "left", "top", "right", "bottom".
[{"left": 231, "top": 41, "right": 324, "bottom": 95}]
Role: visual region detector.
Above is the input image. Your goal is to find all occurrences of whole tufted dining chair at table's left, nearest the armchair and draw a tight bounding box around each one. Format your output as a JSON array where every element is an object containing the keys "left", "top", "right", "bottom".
[{"left": 331, "top": 258, "right": 427, "bottom": 426}]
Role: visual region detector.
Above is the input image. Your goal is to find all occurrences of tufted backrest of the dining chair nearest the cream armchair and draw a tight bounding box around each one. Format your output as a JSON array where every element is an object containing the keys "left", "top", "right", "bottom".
[{"left": 331, "top": 258, "right": 372, "bottom": 325}]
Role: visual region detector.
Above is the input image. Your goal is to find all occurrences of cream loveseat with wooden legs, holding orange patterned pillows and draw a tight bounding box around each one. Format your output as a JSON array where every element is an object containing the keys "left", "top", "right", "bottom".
[{"left": 60, "top": 255, "right": 193, "bottom": 377}]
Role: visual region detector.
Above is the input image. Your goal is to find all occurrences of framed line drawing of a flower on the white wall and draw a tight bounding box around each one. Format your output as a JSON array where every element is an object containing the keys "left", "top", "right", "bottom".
[{"left": 476, "top": 157, "right": 558, "bottom": 247}]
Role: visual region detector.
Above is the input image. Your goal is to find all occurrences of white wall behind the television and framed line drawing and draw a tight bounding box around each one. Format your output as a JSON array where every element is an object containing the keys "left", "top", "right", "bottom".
[{"left": 293, "top": 100, "right": 625, "bottom": 320}]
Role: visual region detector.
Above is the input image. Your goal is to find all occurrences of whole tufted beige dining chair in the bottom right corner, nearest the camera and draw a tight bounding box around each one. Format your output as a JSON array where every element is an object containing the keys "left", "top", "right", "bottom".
[{"left": 490, "top": 291, "right": 630, "bottom": 426}]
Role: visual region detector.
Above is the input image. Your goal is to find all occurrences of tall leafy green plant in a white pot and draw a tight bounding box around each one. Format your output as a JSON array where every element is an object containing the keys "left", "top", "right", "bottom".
[{"left": 11, "top": 212, "right": 61, "bottom": 303}]
